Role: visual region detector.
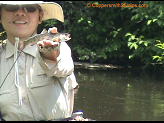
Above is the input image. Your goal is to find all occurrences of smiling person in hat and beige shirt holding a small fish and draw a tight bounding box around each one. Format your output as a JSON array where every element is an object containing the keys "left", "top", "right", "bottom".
[{"left": 0, "top": 1, "right": 82, "bottom": 121}]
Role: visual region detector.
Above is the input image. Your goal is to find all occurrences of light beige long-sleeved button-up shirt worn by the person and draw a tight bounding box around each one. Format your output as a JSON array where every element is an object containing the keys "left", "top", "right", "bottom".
[{"left": 0, "top": 41, "right": 78, "bottom": 121}]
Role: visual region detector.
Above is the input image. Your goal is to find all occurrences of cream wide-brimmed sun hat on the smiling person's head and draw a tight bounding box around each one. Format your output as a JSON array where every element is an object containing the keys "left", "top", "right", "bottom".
[{"left": 0, "top": 1, "right": 64, "bottom": 22}]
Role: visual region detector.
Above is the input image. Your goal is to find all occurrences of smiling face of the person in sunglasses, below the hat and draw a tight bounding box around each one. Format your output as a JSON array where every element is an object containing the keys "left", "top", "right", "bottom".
[{"left": 0, "top": 5, "right": 43, "bottom": 40}]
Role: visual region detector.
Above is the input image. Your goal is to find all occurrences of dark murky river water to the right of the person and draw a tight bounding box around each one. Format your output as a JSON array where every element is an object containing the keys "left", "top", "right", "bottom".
[{"left": 74, "top": 69, "right": 164, "bottom": 121}]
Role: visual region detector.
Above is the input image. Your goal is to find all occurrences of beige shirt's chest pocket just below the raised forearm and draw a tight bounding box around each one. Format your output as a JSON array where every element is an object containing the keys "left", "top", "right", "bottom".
[{"left": 30, "top": 68, "right": 54, "bottom": 88}]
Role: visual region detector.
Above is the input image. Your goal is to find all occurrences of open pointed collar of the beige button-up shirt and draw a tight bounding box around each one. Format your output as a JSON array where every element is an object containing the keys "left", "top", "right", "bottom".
[{"left": 6, "top": 39, "right": 37, "bottom": 58}]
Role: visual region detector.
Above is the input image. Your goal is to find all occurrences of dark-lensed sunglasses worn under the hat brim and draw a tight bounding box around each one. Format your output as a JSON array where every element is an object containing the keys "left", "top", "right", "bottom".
[{"left": 2, "top": 5, "right": 40, "bottom": 12}]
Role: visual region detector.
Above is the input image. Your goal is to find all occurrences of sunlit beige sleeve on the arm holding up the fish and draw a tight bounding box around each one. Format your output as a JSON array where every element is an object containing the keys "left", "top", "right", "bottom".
[{"left": 37, "top": 42, "right": 74, "bottom": 78}]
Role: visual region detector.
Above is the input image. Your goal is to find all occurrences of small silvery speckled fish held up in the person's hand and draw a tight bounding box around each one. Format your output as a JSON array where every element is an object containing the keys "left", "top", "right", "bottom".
[{"left": 20, "top": 28, "right": 71, "bottom": 49}]
